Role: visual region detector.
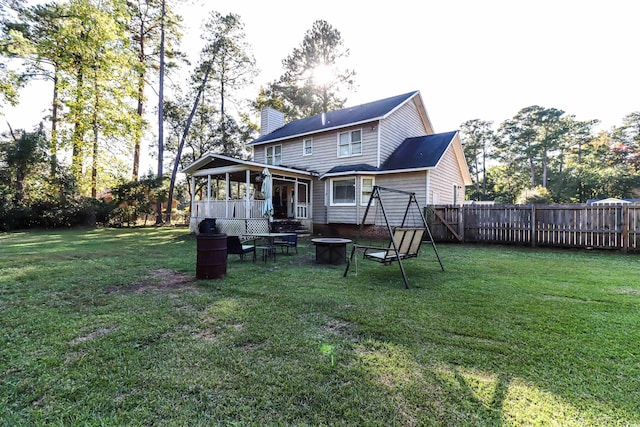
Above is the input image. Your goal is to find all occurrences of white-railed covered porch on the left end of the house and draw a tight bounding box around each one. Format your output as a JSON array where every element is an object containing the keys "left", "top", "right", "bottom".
[{"left": 182, "top": 153, "right": 316, "bottom": 235}]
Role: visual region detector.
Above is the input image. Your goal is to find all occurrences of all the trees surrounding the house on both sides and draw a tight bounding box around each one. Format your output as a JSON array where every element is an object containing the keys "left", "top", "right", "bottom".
[{"left": 0, "top": 0, "right": 640, "bottom": 231}]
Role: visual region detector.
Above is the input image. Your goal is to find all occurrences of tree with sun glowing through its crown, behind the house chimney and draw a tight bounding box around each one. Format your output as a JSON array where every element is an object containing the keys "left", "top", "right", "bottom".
[{"left": 254, "top": 20, "right": 356, "bottom": 120}]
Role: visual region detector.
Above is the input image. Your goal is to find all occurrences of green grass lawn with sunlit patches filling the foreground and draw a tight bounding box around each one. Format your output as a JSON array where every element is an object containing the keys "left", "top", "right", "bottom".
[{"left": 0, "top": 228, "right": 640, "bottom": 426}]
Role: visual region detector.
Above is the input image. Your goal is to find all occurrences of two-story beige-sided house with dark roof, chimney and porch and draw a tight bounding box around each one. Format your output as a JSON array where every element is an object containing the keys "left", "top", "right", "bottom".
[{"left": 183, "top": 91, "right": 471, "bottom": 234}]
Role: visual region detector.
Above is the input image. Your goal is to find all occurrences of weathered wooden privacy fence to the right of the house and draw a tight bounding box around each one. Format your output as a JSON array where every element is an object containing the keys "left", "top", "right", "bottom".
[{"left": 425, "top": 204, "right": 640, "bottom": 252}]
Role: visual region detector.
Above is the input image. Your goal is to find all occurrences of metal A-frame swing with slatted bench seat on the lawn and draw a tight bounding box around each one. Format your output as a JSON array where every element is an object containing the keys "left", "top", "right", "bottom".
[{"left": 343, "top": 185, "right": 444, "bottom": 289}]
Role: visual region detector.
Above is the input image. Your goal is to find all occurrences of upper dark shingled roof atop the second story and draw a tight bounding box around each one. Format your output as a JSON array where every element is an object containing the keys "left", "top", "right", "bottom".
[{"left": 248, "top": 91, "right": 420, "bottom": 145}]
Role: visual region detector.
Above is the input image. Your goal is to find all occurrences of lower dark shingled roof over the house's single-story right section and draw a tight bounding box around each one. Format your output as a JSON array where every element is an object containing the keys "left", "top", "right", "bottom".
[{"left": 320, "top": 131, "right": 458, "bottom": 178}]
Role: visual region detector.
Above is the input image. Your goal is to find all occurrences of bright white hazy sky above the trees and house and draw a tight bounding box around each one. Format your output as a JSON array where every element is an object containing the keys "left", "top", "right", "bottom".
[{"left": 0, "top": 0, "right": 640, "bottom": 167}]
